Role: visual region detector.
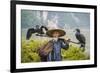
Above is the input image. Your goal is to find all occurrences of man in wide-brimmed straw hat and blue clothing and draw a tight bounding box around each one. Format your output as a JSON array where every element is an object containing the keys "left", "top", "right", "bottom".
[{"left": 40, "top": 29, "right": 69, "bottom": 61}]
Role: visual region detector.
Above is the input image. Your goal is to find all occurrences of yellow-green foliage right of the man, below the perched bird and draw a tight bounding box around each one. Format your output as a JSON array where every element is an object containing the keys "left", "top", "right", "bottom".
[{"left": 61, "top": 45, "right": 89, "bottom": 60}]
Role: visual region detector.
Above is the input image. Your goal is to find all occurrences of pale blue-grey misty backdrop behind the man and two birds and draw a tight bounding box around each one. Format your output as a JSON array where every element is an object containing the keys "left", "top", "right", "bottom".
[{"left": 21, "top": 9, "right": 90, "bottom": 54}]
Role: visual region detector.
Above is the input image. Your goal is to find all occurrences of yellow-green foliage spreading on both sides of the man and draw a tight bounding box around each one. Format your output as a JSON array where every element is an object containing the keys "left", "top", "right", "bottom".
[{"left": 21, "top": 40, "right": 89, "bottom": 63}]
